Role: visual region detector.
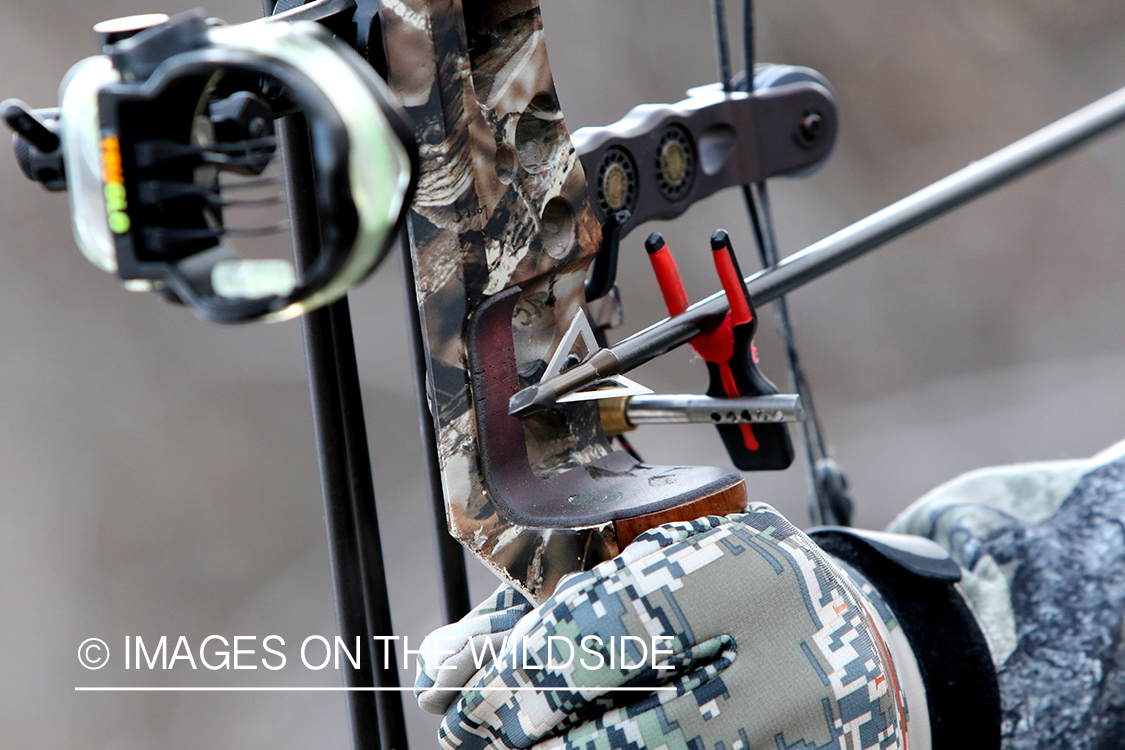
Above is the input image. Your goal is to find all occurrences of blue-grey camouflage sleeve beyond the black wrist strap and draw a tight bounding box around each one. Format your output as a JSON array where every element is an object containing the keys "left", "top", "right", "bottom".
[{"left": 891, "top": 443, "right": 1125, "bottom": 750}]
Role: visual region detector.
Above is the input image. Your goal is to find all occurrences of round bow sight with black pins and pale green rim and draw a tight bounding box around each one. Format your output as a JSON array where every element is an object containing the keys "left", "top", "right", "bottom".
[{"left": 3, "top": 11, "right": 416, "bottom": 322}]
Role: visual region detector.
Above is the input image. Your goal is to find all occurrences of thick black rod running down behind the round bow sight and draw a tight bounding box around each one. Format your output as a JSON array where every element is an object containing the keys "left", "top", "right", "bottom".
[{"left": 279, "top": 116, "right": 406, "bottom": 750}]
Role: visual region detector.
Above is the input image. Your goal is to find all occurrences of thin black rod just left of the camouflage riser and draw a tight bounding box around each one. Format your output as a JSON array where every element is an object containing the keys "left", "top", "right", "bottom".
[{"left": 398, "top": 227, "right": 473, "bottom": 622}]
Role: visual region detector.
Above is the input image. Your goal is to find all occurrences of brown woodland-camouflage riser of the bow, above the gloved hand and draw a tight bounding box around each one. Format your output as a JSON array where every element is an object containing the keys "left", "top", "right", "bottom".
[{"left": 380, "top": 0, "right": 737, "bottom": 600}]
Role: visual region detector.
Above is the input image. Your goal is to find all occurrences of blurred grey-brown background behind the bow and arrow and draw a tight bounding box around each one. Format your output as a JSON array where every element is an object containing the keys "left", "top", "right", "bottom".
[{"left": 0, "top": 0, "right": 1125, "bottom": 750}]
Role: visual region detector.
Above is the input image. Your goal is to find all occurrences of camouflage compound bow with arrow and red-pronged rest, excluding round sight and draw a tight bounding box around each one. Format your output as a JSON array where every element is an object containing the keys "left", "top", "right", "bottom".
[{"left": 6, "top": 0, "right": 1125, "bottom": 748}]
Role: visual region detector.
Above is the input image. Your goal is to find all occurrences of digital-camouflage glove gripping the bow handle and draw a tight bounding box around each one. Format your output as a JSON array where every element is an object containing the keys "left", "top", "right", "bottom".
[{"left": 419, "top": 504, "right": 906, "bottom": 750}]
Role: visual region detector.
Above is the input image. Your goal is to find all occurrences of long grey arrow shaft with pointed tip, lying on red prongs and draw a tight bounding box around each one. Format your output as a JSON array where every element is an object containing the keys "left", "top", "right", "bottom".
[{"left": 509, "top": 88, "right": 1125, "bottom": 417}]
